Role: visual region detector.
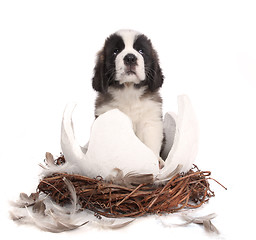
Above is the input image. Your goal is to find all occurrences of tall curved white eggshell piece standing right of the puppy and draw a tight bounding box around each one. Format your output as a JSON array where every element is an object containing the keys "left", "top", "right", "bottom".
[{"left": 157, "top": 95, "right": 199, "bottom": 180}]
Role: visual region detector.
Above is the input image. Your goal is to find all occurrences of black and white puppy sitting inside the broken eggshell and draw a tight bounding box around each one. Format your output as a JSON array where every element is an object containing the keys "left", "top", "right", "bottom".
[{"left": 92, "top": 30, "right": 164, "bottom": 163}]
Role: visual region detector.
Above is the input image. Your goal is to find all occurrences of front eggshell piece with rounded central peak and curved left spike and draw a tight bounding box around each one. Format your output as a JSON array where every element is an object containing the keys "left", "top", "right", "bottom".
[{"left": 61, "top": 105, "right": 159, "bottom": 179}]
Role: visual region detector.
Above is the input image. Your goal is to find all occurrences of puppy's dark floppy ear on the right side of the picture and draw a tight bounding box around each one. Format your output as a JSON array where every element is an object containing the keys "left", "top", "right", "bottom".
[{"left": 147, "top": 50, "right": 164, "bottom": 92}]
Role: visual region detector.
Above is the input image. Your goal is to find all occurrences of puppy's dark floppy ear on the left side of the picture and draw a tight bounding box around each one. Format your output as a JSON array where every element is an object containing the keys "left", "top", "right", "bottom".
[{"left": 92, "top": 49, "right": 108, "bottom": 93}]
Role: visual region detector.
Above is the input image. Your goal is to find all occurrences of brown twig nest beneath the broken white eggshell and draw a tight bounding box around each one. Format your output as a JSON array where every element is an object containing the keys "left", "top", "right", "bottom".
[{"left": 38, "top": 156, "right": 223, "bottom": 218}]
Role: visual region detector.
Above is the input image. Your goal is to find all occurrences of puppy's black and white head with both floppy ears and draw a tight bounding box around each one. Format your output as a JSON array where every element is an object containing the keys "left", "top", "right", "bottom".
[{"left": 92, "top": 30, "right": 164, "bottom": 93}]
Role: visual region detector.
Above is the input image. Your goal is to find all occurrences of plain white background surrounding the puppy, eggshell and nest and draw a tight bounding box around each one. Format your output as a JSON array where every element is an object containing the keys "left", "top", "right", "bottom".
[{"left": 0, "top": 0, "right": 256, "bottom": 239}]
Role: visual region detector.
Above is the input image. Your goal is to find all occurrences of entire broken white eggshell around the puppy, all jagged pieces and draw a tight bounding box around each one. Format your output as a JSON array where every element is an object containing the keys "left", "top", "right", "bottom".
[{"left": 61, "top": 95, "right": 198, "bottom": 181}]
